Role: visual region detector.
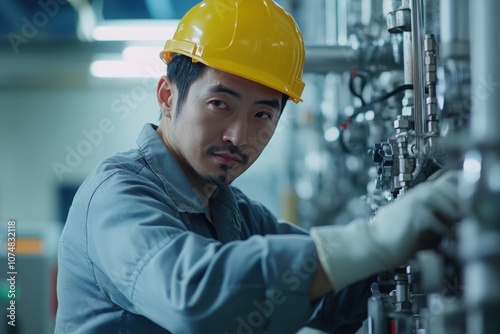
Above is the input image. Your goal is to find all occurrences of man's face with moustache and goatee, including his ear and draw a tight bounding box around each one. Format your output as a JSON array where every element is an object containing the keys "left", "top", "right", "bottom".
[{"left": 159, "top": 67, "right": 283, "bottom": 190}]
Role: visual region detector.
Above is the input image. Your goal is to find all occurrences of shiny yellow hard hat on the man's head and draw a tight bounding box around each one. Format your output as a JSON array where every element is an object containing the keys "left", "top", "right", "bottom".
[{"left": 160, "top": 0, "right": 305, "bottom": 103}]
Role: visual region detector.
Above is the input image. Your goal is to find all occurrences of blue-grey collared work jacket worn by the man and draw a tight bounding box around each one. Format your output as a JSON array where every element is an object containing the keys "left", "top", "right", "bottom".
[{"left": 56, "top": 124, "right": 368, "bottom": 334}]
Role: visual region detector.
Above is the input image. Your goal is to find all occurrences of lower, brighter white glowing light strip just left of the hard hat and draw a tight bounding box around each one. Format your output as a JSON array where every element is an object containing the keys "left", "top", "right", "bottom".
[{"left": 90, "top": 60, "right": 165, "bottom": 78}]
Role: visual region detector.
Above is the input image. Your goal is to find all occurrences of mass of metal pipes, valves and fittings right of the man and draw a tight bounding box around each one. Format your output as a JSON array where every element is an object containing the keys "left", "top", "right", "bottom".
[{"left": 290, "top": 0, "right": 500, "bottom": 334}]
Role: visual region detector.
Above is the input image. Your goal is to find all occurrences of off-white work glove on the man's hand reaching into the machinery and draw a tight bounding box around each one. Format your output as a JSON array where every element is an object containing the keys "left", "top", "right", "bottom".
[{"left": 310, "top": 171, "right": 460, "bottom": 291}]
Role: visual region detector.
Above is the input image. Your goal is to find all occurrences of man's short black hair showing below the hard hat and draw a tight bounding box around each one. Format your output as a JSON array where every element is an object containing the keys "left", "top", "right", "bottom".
[{"left": 167, "top": 54, "right": 289, "bottom": 111}]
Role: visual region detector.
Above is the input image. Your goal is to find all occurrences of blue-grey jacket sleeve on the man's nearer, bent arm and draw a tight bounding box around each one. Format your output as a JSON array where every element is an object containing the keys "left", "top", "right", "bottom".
[{"left": 82, "top": 171, "right": 318, "bottom": 333}]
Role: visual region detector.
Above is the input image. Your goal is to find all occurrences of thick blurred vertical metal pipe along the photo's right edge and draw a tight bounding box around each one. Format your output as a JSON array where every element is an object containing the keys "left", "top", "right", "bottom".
[{"left": 459, "top": 0, "right": 500, "bottom": 334}]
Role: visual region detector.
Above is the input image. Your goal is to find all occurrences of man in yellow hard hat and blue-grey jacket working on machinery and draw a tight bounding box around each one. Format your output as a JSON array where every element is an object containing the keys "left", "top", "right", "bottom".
[{"left": 56, "top": 0, "right": 458, "bottom": 334}]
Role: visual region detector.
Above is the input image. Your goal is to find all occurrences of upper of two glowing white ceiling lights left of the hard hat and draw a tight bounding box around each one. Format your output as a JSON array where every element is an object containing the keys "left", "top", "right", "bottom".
[{"left": 92, "top": 20, "right": 179, "bottom": 42}]
